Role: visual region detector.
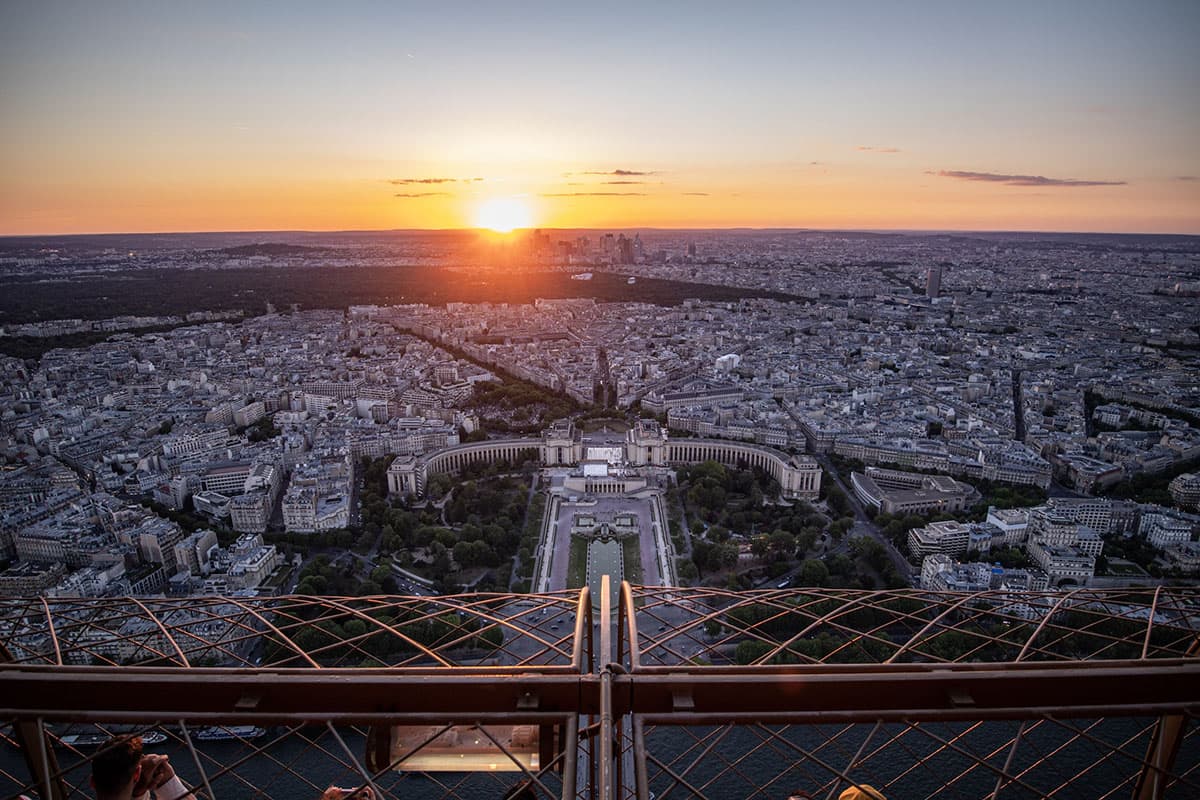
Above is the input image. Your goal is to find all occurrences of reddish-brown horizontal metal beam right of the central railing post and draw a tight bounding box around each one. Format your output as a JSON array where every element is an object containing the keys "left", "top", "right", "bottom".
[{"left": 613, "top": 660, "right": 1200, "bottom": 724}]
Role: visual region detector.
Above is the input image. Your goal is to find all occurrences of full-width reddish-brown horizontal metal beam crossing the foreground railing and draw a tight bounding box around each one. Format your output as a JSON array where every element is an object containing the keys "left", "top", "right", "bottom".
[{"left": 0, "top": 660, "right": 1200, "bottom": 724}]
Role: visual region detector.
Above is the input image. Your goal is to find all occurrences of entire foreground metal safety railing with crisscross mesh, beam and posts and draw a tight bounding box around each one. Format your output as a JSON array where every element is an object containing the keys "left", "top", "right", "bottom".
[{"left": 0, "top": 584, "right": 1200, "bottom": 800}]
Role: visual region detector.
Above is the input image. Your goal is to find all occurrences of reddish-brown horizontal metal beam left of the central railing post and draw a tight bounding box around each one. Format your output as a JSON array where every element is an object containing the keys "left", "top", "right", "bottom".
[{"left": 0, "top": 667, "right": 599, "bottom": 724}]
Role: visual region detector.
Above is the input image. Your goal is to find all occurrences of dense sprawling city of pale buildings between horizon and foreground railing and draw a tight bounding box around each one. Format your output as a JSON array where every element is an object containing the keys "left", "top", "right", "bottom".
[{"left": 0, "top": 230, "right": 1200, "bottom": 614}]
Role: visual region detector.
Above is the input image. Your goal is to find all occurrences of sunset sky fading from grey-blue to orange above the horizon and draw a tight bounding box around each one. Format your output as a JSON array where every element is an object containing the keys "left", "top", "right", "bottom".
[{"left": 0, "top": 0, "right": 1200, "bottom": 234}]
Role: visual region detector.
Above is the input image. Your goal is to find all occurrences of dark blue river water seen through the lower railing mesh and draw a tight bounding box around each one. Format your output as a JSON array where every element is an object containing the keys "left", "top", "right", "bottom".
[{"left": 0, "top": 720, "right": 1180, "bottom": 800}]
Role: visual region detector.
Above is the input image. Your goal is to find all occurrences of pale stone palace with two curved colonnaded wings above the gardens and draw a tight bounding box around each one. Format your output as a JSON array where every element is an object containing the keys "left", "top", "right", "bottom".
[{"left": 388, "top": 420, "right": 821, "bottom": 499}]
